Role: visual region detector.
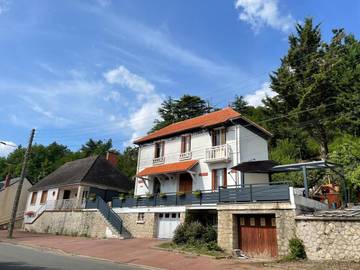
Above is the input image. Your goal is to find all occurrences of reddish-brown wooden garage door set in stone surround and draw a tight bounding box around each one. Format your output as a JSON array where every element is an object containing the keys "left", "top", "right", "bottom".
[{"left": 238, "top": 215, "right": 278, "bottom": 257}]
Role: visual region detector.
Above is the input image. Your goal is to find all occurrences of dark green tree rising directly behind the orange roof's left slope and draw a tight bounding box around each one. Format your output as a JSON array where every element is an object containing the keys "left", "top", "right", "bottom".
[{"left": 150, "top": 95, "right": 213, "bottom": 132}]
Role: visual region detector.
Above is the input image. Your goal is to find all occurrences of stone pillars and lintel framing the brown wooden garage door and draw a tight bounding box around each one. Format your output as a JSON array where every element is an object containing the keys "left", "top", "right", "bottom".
[{"left": 218, "top": 203, "right": 296, "bottom": 256}]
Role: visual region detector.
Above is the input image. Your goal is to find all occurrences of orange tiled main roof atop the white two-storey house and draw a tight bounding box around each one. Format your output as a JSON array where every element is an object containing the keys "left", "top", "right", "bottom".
[{"left": 134, "top": 107, "right": 240, "bottom": 144}]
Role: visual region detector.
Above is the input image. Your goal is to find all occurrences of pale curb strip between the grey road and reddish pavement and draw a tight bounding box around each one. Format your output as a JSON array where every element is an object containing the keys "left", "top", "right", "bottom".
[{"left": 0, "top": 240, "right": 166, "bottom": 270}]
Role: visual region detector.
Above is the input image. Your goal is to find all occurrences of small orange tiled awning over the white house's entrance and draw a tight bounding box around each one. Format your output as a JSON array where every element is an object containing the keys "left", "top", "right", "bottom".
[{"left": 136, "top": 160, "right": 198, "bottom": 177}]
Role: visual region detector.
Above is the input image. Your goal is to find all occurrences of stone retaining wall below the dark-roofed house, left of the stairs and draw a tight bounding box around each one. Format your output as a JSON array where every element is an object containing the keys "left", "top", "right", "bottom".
[{"left": 25, "top": 210, "right": 118, "bottom": 238}]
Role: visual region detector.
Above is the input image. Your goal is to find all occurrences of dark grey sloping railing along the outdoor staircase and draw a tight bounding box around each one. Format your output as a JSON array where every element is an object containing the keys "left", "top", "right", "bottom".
[{"left": 86, "top": 196, "right": 122, "bottom": 234}]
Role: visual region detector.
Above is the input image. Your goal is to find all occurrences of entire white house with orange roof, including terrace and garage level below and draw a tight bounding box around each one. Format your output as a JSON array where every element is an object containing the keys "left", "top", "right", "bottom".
[{"left": 112, "top": 108, "right": 326, "bottom": 257}]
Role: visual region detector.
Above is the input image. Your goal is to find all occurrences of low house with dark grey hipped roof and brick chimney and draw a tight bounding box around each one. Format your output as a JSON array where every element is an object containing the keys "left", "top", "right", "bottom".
[{"left": 25, "top": 153, "right": 133, "bottom": 226}]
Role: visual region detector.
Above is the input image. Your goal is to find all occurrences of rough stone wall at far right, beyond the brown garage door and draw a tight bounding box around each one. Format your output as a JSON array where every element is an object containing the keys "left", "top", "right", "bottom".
[{"left": 296, "top": 217, "right": 360, "bottom": 261}]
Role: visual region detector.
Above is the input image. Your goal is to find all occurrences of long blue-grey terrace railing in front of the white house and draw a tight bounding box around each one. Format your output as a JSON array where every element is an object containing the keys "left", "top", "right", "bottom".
[{"left": 112, "top": 183, "right": 290, "bottom": 207}]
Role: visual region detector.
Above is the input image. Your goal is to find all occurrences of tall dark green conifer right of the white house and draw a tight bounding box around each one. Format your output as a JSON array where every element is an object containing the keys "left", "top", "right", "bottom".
[{"left": 265, "top": 18, "right": 352, "bottom": 159}]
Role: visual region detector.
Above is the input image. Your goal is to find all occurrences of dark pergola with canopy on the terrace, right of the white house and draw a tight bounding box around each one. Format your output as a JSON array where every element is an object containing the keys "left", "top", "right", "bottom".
[{"left": 232, "top": 160, "right": 347, "bottom": 201}]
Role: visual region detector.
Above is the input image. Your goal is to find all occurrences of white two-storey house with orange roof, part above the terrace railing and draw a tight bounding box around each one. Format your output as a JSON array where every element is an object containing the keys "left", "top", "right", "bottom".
[{"left": 135, "top": 108, "right": 271, "bottom": 195}]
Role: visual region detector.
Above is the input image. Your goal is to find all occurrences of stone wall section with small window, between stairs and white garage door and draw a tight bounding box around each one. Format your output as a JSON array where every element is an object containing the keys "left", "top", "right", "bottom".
[{"left": 118, "top": 213, "right": 157, "bottom": 238}]
